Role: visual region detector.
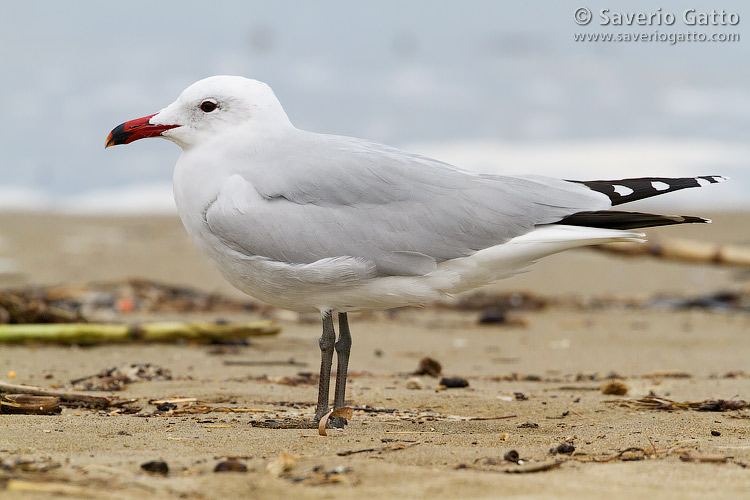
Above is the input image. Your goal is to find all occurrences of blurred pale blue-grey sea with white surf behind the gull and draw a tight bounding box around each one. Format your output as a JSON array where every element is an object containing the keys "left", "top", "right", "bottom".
[{"left": 0, "top": 0, "right": 750, "bottom": 213}]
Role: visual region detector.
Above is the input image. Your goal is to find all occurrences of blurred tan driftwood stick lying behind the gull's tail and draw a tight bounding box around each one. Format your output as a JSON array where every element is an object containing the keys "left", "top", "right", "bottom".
[{"left": 592, "top": 238, "right": 750, "bottom": 267}]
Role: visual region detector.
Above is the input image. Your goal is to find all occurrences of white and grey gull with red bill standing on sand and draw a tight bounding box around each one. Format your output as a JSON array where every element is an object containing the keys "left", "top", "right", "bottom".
[{"left": 106, "top": 76, "right": 724, "bottom": 425}]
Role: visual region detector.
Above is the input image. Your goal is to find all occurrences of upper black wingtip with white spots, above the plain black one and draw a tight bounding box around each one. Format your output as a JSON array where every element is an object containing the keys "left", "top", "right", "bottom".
[{"left": 568, "top": 175, "right": 727, "bottom": 206}]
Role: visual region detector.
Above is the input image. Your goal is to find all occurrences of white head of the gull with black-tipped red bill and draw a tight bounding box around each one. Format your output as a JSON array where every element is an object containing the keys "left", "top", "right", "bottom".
[{"left": 105, "top": 75, "right": 292, "bottom": 149}]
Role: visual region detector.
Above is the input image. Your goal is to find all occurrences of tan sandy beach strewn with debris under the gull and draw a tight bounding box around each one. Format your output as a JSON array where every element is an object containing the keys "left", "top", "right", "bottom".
[{"left": 0, "top": 213, "right": 750, "bottom": 499}]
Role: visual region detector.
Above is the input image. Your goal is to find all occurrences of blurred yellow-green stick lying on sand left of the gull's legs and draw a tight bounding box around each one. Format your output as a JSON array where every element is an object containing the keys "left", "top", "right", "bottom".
[{"left": 0, "top": 320, "right": 281, "bottom": 344}]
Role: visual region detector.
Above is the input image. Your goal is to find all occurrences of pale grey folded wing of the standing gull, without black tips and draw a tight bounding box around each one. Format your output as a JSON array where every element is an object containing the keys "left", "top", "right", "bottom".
[{"left": 206, "top": 131, "right": 611, "bottom": 275}]
